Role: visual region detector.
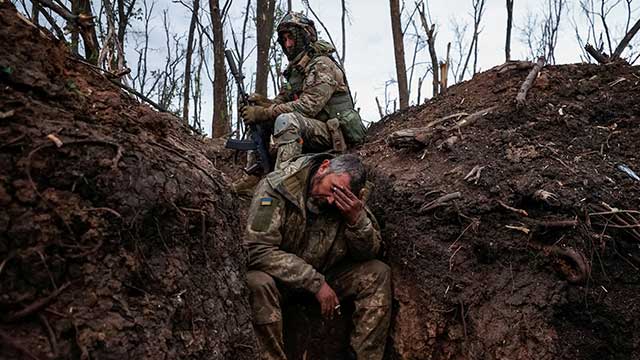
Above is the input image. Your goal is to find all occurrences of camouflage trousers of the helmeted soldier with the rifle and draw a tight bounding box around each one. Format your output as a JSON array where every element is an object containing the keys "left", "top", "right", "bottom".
[{"left": 273, "top": 112, "right": 333, "bottom": 169}]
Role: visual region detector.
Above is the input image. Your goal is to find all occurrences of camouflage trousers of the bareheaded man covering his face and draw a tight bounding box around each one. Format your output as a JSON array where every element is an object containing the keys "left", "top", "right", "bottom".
[{"left": 247, "top": 260, "right": 392, "bottom": 360}]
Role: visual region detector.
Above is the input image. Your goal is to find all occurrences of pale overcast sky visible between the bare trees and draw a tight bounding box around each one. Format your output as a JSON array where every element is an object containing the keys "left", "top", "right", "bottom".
[{"left": 21, "top": 0, "right": 640, "bottom": 132}]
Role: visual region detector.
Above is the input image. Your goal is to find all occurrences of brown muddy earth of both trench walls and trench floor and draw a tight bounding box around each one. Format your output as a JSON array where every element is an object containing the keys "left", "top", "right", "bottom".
[{"left": 0, "top": 2, "right": 640, "bottom": 360}]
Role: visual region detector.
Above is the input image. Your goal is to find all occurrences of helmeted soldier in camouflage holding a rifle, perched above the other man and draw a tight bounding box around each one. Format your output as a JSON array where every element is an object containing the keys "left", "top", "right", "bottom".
[{"left": 235, "top": 12, "right": 365, "bottom": 194}]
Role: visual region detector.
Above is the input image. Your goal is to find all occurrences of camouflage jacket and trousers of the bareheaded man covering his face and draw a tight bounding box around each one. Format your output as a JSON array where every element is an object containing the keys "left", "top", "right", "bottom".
[{"left": 245, "top": 154, "right": 391, "bottom": 360}]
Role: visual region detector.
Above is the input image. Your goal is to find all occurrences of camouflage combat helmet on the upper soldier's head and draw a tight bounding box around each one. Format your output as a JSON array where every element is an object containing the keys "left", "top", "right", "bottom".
[{"left": 277, "top": 11, "right": 318, "bottom": 60}]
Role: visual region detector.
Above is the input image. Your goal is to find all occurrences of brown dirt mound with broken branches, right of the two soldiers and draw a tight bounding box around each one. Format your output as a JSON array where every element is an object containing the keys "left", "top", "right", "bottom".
[{"left": 359, "top": 64, "right": 640, "bottom": 359}]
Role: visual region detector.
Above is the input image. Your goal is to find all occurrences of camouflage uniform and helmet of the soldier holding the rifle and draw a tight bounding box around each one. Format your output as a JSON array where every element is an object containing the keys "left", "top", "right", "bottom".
[{"left": 258, "top": 13, "right": 365, "bottom": 169}]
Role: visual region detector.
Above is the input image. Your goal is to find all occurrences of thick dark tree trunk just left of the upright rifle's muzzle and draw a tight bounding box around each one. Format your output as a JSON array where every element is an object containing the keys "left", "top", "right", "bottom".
[{"left": 209, "top": 0, "right": 231, "bottom": 138}]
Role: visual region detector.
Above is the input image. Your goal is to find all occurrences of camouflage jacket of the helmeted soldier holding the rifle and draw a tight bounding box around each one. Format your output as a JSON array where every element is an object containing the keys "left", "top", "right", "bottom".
[{"left": 271, "top": 40, "right": 353, "bottom": 121}]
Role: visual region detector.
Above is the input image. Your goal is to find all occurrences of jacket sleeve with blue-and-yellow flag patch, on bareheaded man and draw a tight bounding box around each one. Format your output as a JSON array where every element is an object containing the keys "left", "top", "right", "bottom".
[{"left": 244, "top": 179, "right": 324, "bottom": 294}]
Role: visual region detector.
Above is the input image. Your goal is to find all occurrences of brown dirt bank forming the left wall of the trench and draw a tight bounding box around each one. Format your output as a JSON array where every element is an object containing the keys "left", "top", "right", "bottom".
[{"left": 0, "top": 2, "right": 256, "bottom": 359}]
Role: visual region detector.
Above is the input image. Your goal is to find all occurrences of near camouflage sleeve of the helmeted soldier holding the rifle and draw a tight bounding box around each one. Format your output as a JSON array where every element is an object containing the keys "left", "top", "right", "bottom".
[{"left": 271, "top": 57, "right": 339, "bottom": 118}]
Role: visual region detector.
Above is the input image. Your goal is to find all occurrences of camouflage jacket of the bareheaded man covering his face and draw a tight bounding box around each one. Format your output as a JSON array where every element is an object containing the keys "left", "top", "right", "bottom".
[{"left": 244, "top": 154, "right": 381, "bottom": 294}]
